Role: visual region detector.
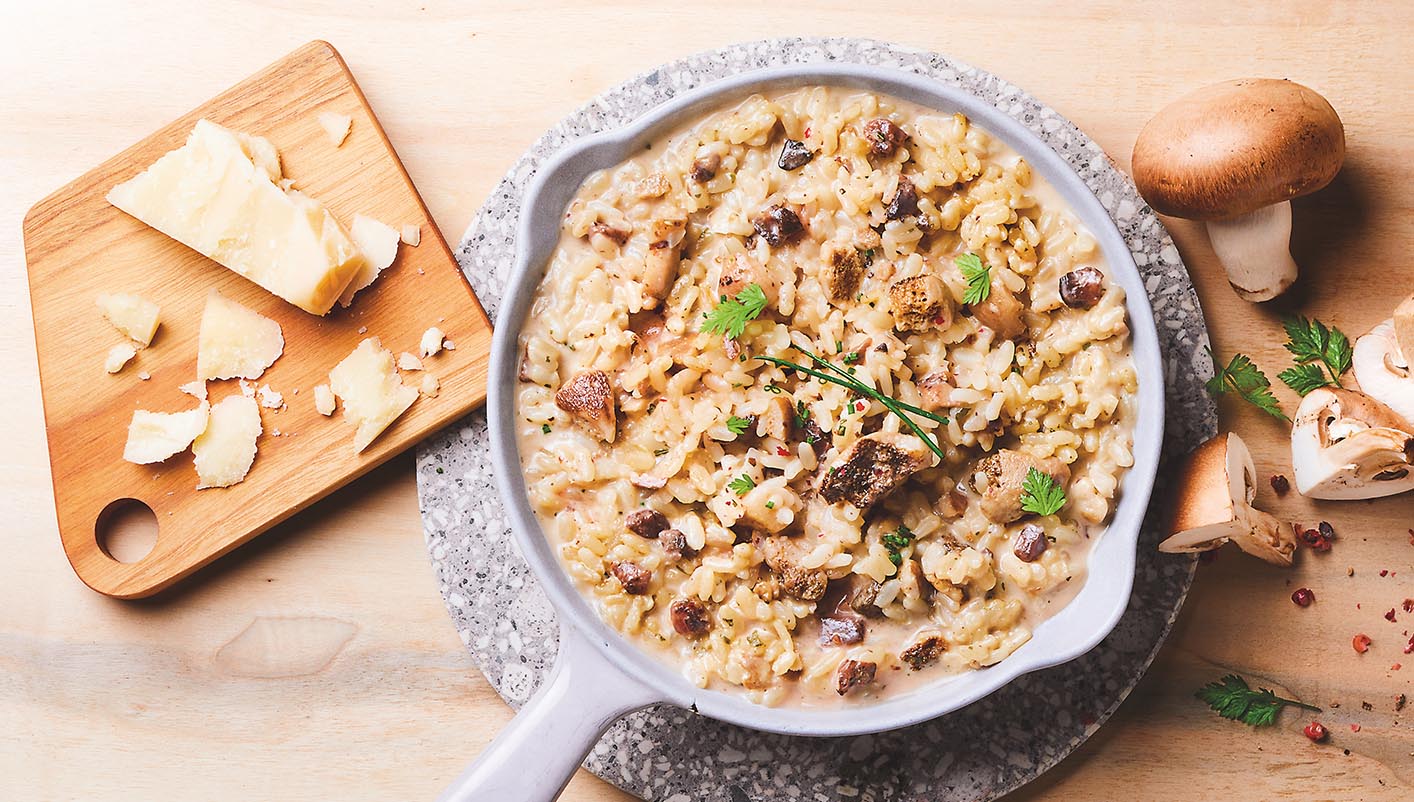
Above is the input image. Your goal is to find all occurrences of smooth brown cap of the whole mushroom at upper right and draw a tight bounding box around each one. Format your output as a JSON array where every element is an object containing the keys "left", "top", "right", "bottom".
[{"left": 1131, "top": 78, "right": 1345, "bottom": 221}]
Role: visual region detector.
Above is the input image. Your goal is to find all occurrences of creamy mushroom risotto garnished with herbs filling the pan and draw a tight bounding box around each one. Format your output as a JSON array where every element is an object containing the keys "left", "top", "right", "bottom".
[{"left": 516, "top": 86, "right": 1137, "bottom": 704}]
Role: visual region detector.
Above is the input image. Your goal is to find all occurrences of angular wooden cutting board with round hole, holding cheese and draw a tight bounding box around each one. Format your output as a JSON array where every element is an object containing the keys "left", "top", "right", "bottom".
[{"left": 24, "top": 41, "right": 491, "bottom": 598}]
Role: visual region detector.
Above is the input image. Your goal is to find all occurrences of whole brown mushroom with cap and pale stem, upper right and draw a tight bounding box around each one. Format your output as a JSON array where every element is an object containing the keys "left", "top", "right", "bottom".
[{"left": 1133, "top": 78, "right": 1345, "bottom": 301}]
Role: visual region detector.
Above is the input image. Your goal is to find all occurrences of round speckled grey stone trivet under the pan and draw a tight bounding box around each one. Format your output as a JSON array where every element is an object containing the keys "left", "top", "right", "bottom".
[{"left": 417, "top": 38, "right": 1216, "bottom": 802}]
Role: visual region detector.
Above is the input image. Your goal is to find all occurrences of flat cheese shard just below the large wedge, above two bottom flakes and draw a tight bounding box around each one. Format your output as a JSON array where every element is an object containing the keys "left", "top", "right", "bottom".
[{"left": 197, "top": 290, "right": 284, "bottom": 380}]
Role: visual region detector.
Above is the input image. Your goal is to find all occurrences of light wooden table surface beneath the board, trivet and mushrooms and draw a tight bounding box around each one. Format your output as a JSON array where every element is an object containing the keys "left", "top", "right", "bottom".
[{"left": 0, "top": 0, "right": 1414, "bottom": 801}]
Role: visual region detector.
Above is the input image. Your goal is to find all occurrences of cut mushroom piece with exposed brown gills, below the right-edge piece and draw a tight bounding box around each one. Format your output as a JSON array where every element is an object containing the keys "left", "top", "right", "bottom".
[{"left": 1291, "top": 388, "right": 1414, "bottom": 499}]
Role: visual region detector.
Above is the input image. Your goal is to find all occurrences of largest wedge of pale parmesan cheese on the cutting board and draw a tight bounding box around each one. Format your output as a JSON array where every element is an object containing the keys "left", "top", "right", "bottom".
[{"left": 107, "top": 120, "right": 363, "bottom": 315}]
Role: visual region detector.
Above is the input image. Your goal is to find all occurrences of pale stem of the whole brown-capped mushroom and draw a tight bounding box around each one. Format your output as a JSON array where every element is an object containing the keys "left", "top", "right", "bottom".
[{"left": 1208, "top": 201, "right": 1297, "bottom": 301}]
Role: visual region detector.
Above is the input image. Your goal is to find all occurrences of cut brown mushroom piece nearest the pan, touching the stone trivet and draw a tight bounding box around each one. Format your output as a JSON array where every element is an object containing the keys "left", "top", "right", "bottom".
[{"left": 1158, "top": 433, "right": 1297, "bottom": 566}]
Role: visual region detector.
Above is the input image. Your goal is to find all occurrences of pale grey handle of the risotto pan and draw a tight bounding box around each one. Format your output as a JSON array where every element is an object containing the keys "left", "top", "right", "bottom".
[{"left": 437, "top": 627, "right": 663, "bottom": 802}]
